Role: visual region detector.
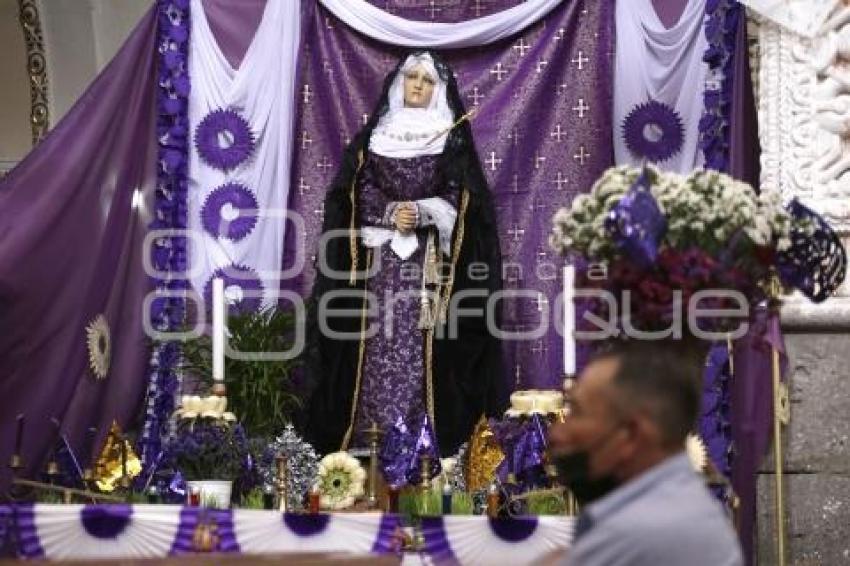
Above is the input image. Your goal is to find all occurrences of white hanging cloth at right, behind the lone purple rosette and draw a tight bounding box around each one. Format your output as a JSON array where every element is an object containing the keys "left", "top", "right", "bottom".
[{"left": 613, "top": 0, "right": 708, "bottom": 173}]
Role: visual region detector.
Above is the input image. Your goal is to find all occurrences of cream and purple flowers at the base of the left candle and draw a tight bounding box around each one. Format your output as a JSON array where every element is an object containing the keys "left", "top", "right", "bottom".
[{"left": 163, "top": 395, "right": 250, "bottom": 481}]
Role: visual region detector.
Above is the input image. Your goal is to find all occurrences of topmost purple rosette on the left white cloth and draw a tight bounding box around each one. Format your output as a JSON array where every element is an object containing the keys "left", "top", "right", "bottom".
[{"left": 195, "top": 108, "right": 255, "bottom": 171}]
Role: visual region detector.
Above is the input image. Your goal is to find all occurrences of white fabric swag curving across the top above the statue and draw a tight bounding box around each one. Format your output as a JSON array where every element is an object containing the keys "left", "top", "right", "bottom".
[{"left": 319, "top": 0, "right": 564, "bottom": 48}]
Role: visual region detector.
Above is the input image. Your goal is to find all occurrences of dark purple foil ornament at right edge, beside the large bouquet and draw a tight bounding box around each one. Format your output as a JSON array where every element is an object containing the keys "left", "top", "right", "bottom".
[{"left": 776, "top": 198, "right": 847, "bottom": 303}]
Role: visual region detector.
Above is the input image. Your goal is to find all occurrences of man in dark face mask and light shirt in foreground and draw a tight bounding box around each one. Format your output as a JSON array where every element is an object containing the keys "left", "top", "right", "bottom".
[{"left": 550, "top": 342, "right": 743, "bottom": 566}]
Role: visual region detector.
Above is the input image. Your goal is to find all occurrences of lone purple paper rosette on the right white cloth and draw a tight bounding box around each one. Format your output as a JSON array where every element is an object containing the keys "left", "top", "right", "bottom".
[{"left": 622, "top": 100, "right": 685, "bottom": 163}]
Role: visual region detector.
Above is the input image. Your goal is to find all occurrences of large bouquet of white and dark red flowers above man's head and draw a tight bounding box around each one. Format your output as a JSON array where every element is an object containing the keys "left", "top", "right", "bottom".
[{"left": 550, "top": 166, "right": 814, "bottom": 330}]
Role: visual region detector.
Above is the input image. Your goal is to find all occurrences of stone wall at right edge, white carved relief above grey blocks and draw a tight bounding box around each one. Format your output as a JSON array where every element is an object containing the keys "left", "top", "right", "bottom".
[{"left": 747, "top": 0, "right": 850, "bottom": 565}]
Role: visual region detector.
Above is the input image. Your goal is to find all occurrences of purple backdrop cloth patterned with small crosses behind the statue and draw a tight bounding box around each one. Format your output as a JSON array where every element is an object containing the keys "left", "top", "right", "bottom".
[{"left": 284, "top": 0, "right": 613, "bottom": 388}]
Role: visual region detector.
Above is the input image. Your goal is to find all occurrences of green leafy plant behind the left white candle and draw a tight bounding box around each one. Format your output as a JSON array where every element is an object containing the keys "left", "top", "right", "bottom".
[{"left": 182, "top": 308, "right": 301, "bottom": 438}]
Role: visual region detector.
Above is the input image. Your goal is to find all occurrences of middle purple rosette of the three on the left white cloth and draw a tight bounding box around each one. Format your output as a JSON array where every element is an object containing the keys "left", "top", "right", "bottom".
[{"left": 201, "top": 183, "right": 260, "bottom": 242}]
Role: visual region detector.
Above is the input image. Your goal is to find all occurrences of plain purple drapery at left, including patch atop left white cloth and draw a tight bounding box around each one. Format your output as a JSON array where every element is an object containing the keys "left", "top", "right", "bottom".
[{"left": 0, "top": 0, "right": 265, "bottom": 491}]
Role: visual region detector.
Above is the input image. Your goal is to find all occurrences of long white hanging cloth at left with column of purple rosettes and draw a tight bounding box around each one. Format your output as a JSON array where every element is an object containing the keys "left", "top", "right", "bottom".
[{"left": 188, "top": 0, "right": 300, "bottom": 310}]
